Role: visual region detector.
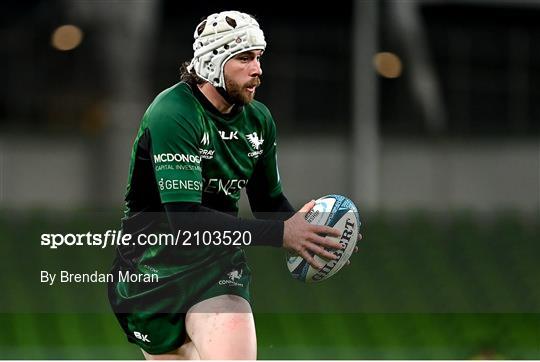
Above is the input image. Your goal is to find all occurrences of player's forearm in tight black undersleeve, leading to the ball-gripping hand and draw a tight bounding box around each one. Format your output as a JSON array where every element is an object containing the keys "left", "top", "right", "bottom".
[{"left": 164, "top": 202, "right": 283, "bottom": 247}]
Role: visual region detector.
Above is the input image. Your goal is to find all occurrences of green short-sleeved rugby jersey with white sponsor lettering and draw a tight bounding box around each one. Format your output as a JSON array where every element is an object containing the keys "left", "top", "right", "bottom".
[{"left": 126, "top": 83, "right": 281, "bottom": 216}]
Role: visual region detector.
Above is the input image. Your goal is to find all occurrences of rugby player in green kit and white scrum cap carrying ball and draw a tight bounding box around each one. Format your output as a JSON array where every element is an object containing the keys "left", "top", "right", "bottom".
[{"left": 109, "top": 11, "right": 358, "bottom": 359}]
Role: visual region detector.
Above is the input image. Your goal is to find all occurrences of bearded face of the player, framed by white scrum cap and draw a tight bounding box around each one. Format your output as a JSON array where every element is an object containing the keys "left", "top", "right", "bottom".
[{"left": 223, "top": 50, "right": 262, "bottom": 104}]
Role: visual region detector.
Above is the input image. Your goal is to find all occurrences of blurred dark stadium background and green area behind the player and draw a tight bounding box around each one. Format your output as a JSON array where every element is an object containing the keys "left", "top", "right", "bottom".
[{"left": 0, "top": 0, "right": 540, "bottom": 359}]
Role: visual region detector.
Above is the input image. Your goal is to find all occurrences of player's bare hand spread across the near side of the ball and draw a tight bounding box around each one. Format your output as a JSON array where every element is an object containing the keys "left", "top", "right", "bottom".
[{"left": 283, "top": 200, "right": 342, "bottom": 269}]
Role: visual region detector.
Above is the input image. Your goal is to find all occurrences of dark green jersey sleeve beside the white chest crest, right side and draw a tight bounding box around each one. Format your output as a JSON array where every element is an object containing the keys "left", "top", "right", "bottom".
[{"left": 246, "top": 112, "right": 282, "bottom": 198}]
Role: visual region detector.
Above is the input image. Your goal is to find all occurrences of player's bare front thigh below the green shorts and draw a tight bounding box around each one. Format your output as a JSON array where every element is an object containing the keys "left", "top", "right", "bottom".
[{"left": 186, "top": 295, "right": 257, "bottom": 360}]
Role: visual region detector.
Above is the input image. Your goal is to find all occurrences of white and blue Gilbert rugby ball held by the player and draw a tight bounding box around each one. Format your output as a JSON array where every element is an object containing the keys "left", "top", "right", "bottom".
[{"left": 287, "top": 195, "right": 361, "bottom": 283}]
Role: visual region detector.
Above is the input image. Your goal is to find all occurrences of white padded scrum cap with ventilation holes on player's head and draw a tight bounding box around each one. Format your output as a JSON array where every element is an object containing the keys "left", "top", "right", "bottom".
[{"left": 188, "top": 11, "right": 266, "bottom": 88}]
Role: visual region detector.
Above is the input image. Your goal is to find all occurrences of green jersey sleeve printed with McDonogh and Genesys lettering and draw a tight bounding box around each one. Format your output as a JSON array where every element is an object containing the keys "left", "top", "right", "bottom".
[{"left": 147, "top": 107, "right": 203, "bottom": 203}]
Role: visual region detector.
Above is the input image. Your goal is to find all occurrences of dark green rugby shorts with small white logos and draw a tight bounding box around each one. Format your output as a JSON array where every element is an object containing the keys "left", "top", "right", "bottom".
[{"left": 108, "top": 249, "right": 251, "bottom": 354}]
